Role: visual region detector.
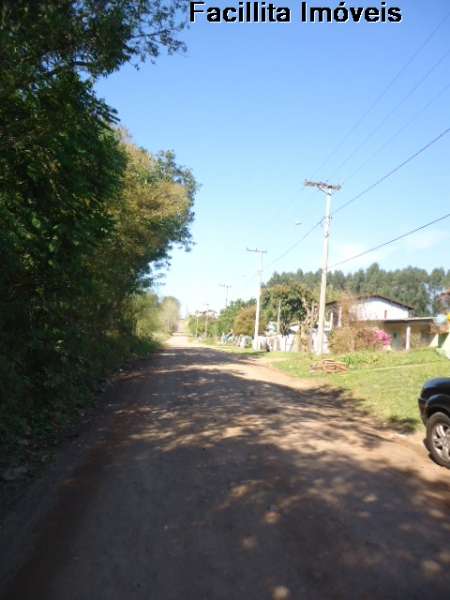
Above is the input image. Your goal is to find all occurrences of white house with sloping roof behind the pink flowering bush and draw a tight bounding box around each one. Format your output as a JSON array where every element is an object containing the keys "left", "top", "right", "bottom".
[{"left": 325, "top": 294, "right": 435, "bottom": 350}]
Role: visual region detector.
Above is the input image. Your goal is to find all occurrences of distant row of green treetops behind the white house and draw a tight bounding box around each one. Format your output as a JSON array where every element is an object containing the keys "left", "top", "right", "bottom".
[{"left": 267, "top": 263, "right": 450, "bottom": 316}]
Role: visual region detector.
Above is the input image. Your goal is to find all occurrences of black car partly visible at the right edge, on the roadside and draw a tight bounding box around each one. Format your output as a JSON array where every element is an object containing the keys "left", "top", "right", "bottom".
[{"left": 419, "top": 377, "right": 450, "bottom": 469}]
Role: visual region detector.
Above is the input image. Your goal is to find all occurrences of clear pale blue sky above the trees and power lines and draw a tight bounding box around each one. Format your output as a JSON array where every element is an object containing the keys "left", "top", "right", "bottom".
[{"left": 97, "top": 0, "right": 450, "bottom": 311}]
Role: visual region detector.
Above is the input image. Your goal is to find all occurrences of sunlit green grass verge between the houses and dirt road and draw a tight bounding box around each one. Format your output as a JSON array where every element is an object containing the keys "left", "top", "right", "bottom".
[{"left": 266, "top": 349, "right": 450, "bottom": 431}]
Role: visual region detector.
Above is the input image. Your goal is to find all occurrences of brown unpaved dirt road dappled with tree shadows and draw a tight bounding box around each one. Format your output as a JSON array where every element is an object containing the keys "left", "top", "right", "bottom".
[{"left": 0, "top": 337, "right": 450, "bottom": 600}]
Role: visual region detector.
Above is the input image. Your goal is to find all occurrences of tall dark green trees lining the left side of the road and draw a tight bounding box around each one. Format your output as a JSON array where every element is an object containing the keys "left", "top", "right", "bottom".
[{"left": 0, "top": 0, "right": 191, "bottom": 450}]
